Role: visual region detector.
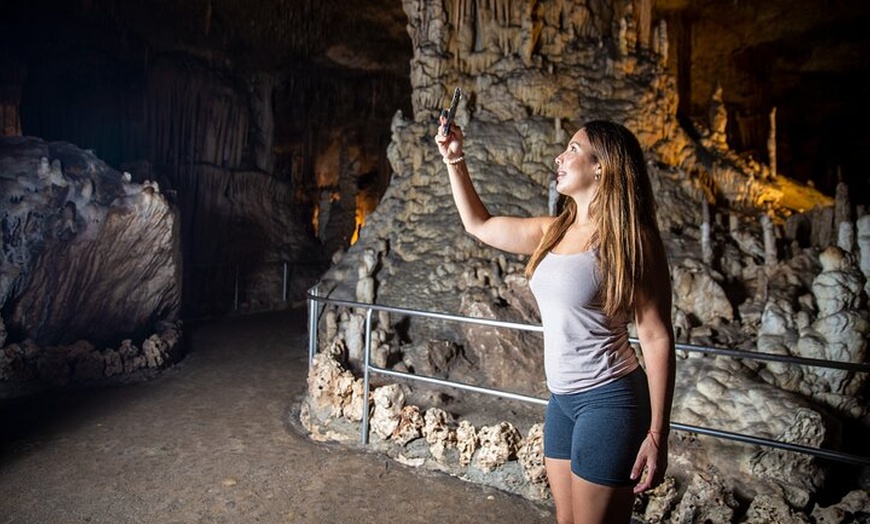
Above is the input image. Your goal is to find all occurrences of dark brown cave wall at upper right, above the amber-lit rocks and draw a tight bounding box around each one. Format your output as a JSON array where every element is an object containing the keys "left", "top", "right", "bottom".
[{"left": 655, "top": 0, "right": 870, "bottom": 206}]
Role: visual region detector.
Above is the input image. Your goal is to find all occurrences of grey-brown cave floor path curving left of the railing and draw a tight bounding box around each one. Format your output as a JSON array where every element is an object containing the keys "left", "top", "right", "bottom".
[{"left": 0, "top": 309, "right": 555, "bottom": 524}]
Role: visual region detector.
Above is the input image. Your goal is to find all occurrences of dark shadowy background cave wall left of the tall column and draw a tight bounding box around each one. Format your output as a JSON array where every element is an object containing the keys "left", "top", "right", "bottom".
[{"left": 0, "top": 0, "right": 418, "bottom": 316}]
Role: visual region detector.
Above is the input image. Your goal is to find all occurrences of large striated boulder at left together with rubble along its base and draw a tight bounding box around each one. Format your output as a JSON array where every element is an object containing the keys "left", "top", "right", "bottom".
[{"left": 0, "top": 137, "right": 181, "bottom": 395}]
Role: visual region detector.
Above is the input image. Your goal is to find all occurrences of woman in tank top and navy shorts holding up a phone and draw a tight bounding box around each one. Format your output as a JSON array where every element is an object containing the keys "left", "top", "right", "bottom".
[{"left": 435, "top": 117, "right": 675, "bottom": 524}]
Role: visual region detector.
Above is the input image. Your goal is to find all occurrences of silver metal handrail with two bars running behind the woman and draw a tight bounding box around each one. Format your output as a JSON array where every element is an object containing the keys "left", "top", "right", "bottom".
[{"left": 306, "top": 286, "right": 870, "bottom": 466}]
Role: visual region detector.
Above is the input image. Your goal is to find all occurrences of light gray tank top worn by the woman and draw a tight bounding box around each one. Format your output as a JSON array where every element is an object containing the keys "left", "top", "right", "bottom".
[{"left": 529, "top": 250, "right": 639, "bottom": 395}]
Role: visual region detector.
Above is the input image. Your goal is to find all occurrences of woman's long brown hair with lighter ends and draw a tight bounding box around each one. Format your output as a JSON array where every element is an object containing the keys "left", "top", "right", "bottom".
[{"left": 526, "top": 120, "right": 661, "bottom": 316}]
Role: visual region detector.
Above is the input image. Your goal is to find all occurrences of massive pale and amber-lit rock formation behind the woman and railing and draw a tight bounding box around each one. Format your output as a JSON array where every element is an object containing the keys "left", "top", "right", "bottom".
[{"left": 306, "top": 0, "right": 868, "bottom": 522}]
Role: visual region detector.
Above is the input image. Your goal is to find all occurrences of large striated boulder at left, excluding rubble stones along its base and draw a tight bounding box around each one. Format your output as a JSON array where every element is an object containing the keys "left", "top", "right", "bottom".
[{"left": 0, "top": 138, "right": 181, "bottom": 344}]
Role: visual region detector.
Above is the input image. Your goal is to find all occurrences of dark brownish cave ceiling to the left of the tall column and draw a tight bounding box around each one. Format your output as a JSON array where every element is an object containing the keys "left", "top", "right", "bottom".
[{"left": 0, "top": 0, "right": 411, "bottom": 75}]
